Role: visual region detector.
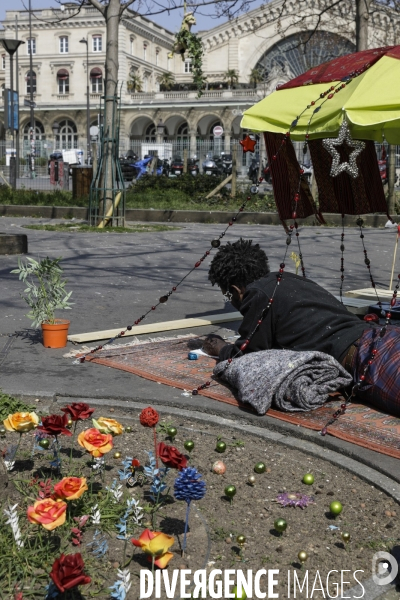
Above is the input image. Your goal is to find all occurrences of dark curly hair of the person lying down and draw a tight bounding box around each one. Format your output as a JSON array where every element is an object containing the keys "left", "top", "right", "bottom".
[{"left": 208, "top": 238, "right": 269, "bottom": 290}]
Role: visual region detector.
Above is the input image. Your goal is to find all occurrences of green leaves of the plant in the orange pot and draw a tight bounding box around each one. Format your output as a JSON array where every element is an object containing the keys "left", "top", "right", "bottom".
[{"left": 11, "top": 256, "right": 72, "bottom": 327}]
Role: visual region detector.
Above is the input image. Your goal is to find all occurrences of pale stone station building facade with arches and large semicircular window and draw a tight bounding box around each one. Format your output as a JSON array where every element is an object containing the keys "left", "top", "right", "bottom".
[{"left": 0, "top": 0, "right": 398, "bottom": 159}]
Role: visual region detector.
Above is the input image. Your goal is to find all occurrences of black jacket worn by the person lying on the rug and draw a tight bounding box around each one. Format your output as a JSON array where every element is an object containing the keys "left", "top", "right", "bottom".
[{"left": 219, "top": 273, "right": 369, "bottom": 361}]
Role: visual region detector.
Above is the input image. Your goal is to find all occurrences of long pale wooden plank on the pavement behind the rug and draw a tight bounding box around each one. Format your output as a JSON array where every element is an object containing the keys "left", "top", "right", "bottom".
[{"left": 68, "top": 312, "right": 243, "bottom": 344}]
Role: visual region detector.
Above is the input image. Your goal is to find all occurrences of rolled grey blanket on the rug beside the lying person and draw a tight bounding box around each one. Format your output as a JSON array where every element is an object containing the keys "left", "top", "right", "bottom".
[{"left": 214, "top": 350, "right": 352, "bottom": 415}]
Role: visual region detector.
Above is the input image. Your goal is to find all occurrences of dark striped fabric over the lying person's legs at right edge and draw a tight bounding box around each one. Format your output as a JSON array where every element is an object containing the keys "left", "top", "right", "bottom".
[{"left": 351, "top": 325, "right": 400, "bottom": 417}]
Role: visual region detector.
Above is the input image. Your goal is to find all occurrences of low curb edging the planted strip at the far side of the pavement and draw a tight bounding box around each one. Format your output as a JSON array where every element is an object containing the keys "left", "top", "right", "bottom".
[{"left": 0, "top": 204, "right": 388, "bottom": 227}]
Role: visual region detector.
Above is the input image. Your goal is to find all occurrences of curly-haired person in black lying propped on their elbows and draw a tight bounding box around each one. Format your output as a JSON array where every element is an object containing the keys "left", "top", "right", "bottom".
[{"left": 203, "top": 239, "right": 400, "bottom": 416}]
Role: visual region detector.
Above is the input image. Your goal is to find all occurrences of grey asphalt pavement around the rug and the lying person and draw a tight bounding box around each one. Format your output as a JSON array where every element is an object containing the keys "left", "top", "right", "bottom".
[{"left": 0, "top": 217, "right": 400, "bottom": 600}]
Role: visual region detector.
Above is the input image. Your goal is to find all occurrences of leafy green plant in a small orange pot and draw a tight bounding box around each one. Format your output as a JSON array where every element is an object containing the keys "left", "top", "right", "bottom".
[{"left": 11, "top": 257, "right": 72, "bottom": 348}]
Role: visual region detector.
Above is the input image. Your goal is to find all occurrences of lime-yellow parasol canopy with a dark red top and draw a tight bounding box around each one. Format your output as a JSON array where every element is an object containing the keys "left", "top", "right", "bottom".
[{"left": 241, "top": 46, "right": 400, "bottom": 144}]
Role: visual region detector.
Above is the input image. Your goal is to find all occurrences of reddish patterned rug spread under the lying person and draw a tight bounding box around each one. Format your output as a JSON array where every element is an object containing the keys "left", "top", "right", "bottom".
[{"left": 86, "top": 336, "right": 400, "bottom": 458}]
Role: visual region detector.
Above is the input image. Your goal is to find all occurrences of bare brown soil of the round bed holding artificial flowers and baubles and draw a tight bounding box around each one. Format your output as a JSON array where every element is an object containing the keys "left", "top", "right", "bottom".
[{"left": 0, "top": 400, "right": 400, "bottom": 600}]
